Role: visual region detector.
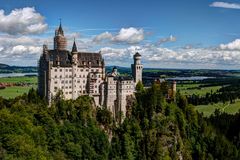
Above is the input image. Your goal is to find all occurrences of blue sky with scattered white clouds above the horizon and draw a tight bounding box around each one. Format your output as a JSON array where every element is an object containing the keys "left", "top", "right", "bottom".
[{"left": 0, "top": 0, "right": 240, "bottom": 69}]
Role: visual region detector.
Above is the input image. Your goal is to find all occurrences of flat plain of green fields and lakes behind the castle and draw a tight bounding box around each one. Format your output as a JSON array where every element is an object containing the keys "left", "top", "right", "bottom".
[{"left": 0, "top": 64, "right": 240, "bottom": 116}]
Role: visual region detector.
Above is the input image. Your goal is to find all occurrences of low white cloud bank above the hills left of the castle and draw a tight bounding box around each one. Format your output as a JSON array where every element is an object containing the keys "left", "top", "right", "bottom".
[{"left": 0, "top": 35, "right": 46, "bottom": 66}]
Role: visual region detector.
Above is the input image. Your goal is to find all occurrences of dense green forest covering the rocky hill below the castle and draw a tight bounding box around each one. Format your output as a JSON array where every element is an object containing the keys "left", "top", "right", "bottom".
[{"left": 0, "top": 83, "right": 240, "bottom": 160}]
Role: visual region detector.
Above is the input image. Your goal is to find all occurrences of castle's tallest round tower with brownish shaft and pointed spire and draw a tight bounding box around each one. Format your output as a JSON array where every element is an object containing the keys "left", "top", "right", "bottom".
[{"left": 54, "top": 21, "right": 67, "bottom": 50}]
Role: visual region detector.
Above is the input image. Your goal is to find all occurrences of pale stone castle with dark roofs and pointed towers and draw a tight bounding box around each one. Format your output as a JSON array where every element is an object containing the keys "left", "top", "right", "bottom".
[{"left": 38, "top": 23, "right": 143, "bottom": 118}]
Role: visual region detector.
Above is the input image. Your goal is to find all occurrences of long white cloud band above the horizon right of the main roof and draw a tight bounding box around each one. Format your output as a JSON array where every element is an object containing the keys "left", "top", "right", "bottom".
[{"left": 101, "top": 45, "right": 240, "bottom": 69}]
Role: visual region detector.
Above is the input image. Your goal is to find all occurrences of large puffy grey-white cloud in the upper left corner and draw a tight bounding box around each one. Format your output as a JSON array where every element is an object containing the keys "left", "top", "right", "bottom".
[{"left": 0, "top": 7, "right": 47, "bottom": 35}]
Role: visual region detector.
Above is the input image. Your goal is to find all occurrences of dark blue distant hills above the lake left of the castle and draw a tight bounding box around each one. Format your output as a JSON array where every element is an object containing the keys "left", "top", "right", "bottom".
[{"left": 0, "top": 63, "right": 37, "bottom": 73}]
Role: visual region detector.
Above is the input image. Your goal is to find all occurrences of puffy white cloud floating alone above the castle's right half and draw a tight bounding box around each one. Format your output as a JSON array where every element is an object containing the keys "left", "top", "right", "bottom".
[{"left": 93, "top": 27, "right": 144, "bottom": 44}]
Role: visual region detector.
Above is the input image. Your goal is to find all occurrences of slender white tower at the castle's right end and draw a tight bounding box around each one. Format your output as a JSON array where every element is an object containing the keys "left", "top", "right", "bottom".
[{"left": 132, "top": 52, "right": 143, "bottom": 84}]
